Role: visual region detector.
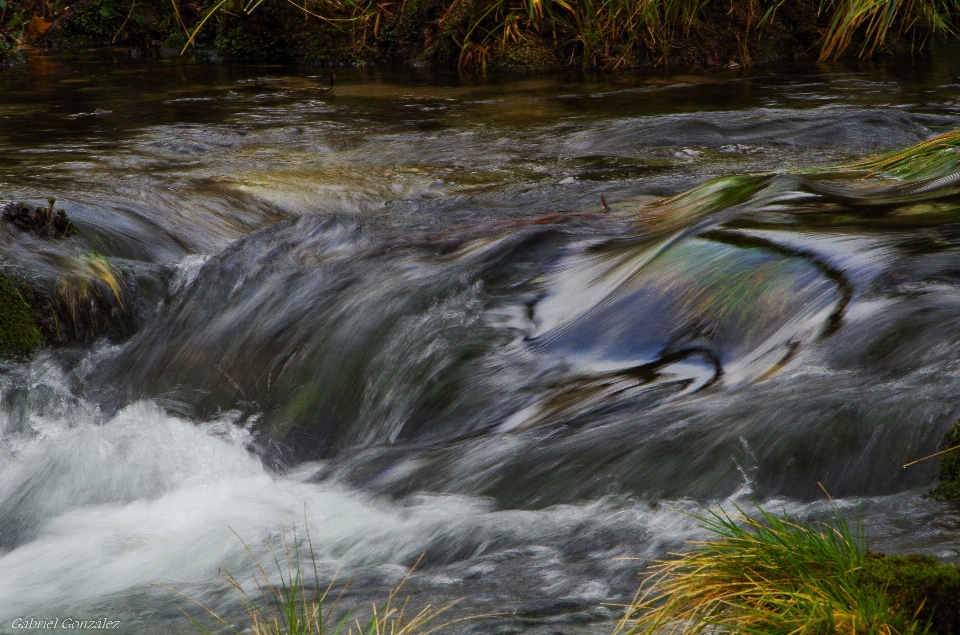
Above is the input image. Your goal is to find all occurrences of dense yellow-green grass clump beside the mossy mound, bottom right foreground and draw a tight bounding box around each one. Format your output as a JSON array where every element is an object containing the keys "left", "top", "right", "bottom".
[{"left": 618, "top": 510, "right": 927, "bottom": 635}]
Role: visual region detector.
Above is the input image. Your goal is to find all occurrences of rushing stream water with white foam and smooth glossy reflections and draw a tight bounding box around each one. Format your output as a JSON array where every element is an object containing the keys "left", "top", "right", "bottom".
[{"left": 0, "top": 50, "right": 960, "bottom": 633}]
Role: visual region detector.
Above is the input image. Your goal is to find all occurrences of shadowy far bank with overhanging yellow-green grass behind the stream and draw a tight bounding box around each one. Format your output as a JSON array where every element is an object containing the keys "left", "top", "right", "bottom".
[{"left": 0, "top": 0, "right": 960, "bottom": 70}]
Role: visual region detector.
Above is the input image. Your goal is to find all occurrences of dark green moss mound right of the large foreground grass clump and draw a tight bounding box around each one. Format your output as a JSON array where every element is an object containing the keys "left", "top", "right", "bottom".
[{"left": 860, "top": 554, "right": 960, "bottom": 635}]
